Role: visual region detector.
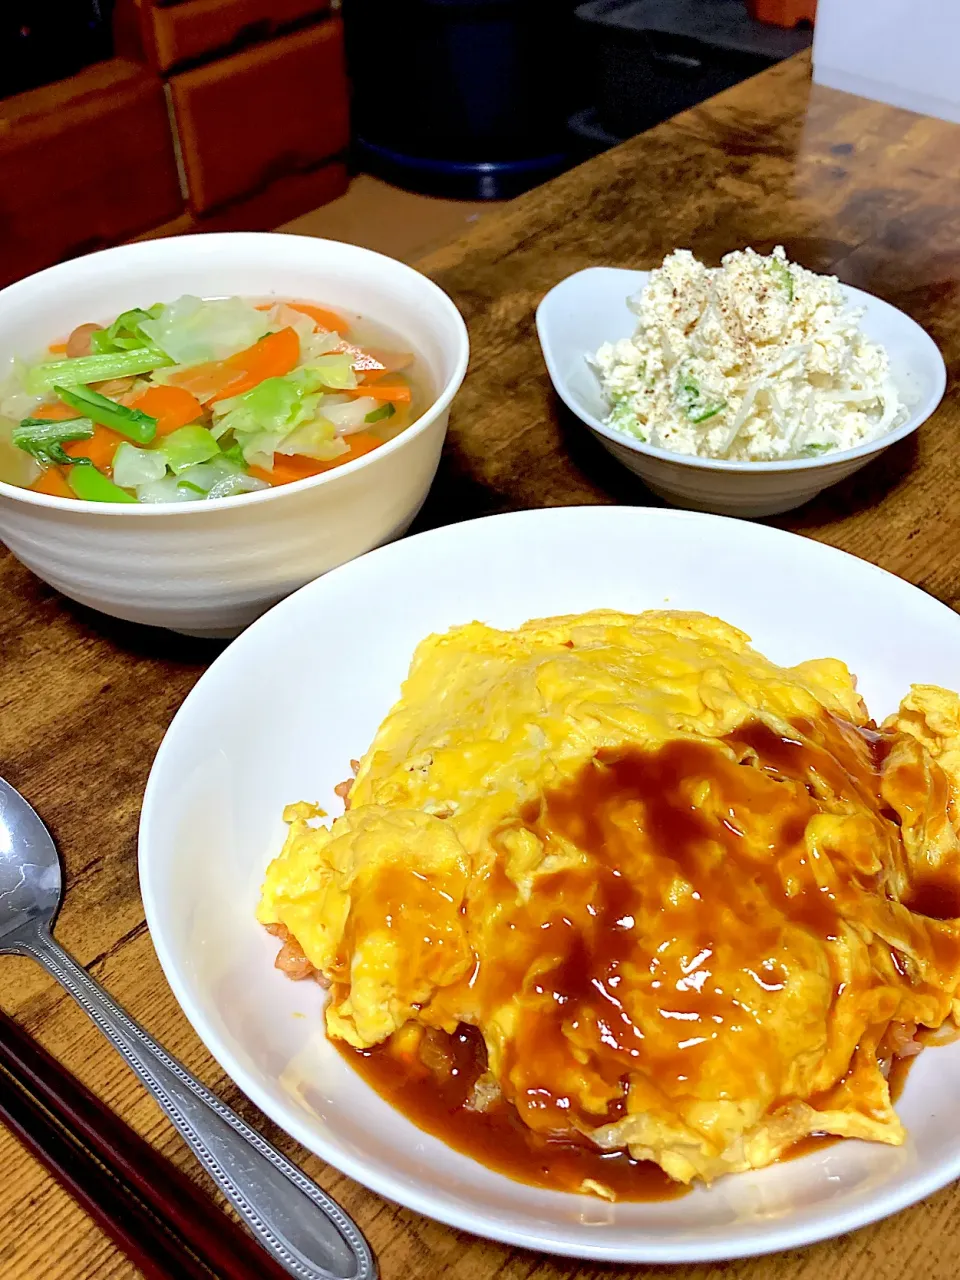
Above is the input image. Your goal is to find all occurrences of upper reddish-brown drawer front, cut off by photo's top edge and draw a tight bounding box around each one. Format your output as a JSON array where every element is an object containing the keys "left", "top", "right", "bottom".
[{"left": 142, "top": 0, "right": 330, "bottom": 72}]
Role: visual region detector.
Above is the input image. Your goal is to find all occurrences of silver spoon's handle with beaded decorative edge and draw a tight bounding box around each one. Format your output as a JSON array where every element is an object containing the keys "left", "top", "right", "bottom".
[{"left": 23, "top": 929, "right": 376, "bottom": 1280}]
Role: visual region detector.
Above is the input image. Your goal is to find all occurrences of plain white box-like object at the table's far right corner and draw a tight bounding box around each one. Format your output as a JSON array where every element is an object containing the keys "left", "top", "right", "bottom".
[{"left": 813, "top": 0, "right": 960, "bottom": 122}]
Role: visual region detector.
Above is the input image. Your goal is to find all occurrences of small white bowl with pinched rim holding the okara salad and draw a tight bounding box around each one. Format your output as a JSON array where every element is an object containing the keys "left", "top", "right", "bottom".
[{"left": 536, "top": 266, "right": 947, "bottom": 516}]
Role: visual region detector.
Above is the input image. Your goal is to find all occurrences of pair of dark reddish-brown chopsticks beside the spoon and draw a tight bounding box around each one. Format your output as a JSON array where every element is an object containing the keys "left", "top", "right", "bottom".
[{"left": 0, "top": 1011, "right": 289, "bottom": 1280}]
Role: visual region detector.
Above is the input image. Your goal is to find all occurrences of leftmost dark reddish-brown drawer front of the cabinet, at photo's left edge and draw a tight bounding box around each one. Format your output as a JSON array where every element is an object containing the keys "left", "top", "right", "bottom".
[{"left": 0, "top": 59, "right": 183, "bottom": 284}]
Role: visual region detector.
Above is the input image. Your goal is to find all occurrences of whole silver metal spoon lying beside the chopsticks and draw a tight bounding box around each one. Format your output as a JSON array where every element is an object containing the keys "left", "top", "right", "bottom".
[{"left": 0, "top": 778, "right": 376, "bottom": 1280}]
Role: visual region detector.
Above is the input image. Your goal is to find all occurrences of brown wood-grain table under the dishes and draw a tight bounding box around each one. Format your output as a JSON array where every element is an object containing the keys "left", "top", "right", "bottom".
[{"left": 0, "top": 49, "right": 960, "bottom": 1280}]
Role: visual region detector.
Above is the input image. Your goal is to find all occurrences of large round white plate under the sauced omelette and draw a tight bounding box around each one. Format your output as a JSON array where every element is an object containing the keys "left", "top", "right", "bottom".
[{"left": 140, "top": 507, "right": 960, "bottom": 1262}]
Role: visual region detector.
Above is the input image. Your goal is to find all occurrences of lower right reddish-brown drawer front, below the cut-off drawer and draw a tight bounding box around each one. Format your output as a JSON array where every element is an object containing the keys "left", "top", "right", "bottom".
[{"left": 168, "top": 19, "right": 349, "bottom": 212}]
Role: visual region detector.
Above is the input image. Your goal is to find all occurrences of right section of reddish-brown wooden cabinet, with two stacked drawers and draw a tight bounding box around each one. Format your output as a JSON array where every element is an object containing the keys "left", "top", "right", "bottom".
[{"left": 122, "top": 0, "right": 349, "bottom": 227}]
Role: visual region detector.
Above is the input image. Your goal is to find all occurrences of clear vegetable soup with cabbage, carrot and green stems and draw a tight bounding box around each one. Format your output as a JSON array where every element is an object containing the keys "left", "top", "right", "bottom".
[{"left": 0, "top": 297, "right": 422, "bottom": 503}]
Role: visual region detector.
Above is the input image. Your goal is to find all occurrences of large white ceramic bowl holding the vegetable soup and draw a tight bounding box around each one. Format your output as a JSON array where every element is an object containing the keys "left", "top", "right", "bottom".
[{"left": 0, "top": 232, "right": 470, "bottom": 636}]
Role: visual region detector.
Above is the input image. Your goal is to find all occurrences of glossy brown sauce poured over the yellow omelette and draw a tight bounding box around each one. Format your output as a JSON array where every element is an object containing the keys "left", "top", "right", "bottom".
[{"left": 338, "top": 717, "right": 960, "bottom": 1201}]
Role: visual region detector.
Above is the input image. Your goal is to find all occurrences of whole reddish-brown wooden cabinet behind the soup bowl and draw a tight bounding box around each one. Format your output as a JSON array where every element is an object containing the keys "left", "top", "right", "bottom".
[{"left": 0, "top": 0, "right": 349, "bottom": 285}]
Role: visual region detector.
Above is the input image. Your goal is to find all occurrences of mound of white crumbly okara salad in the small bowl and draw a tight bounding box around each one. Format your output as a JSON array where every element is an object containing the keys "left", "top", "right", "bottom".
[{"left": 591, "top": 247, "right": 906, "bottom": 461}]
